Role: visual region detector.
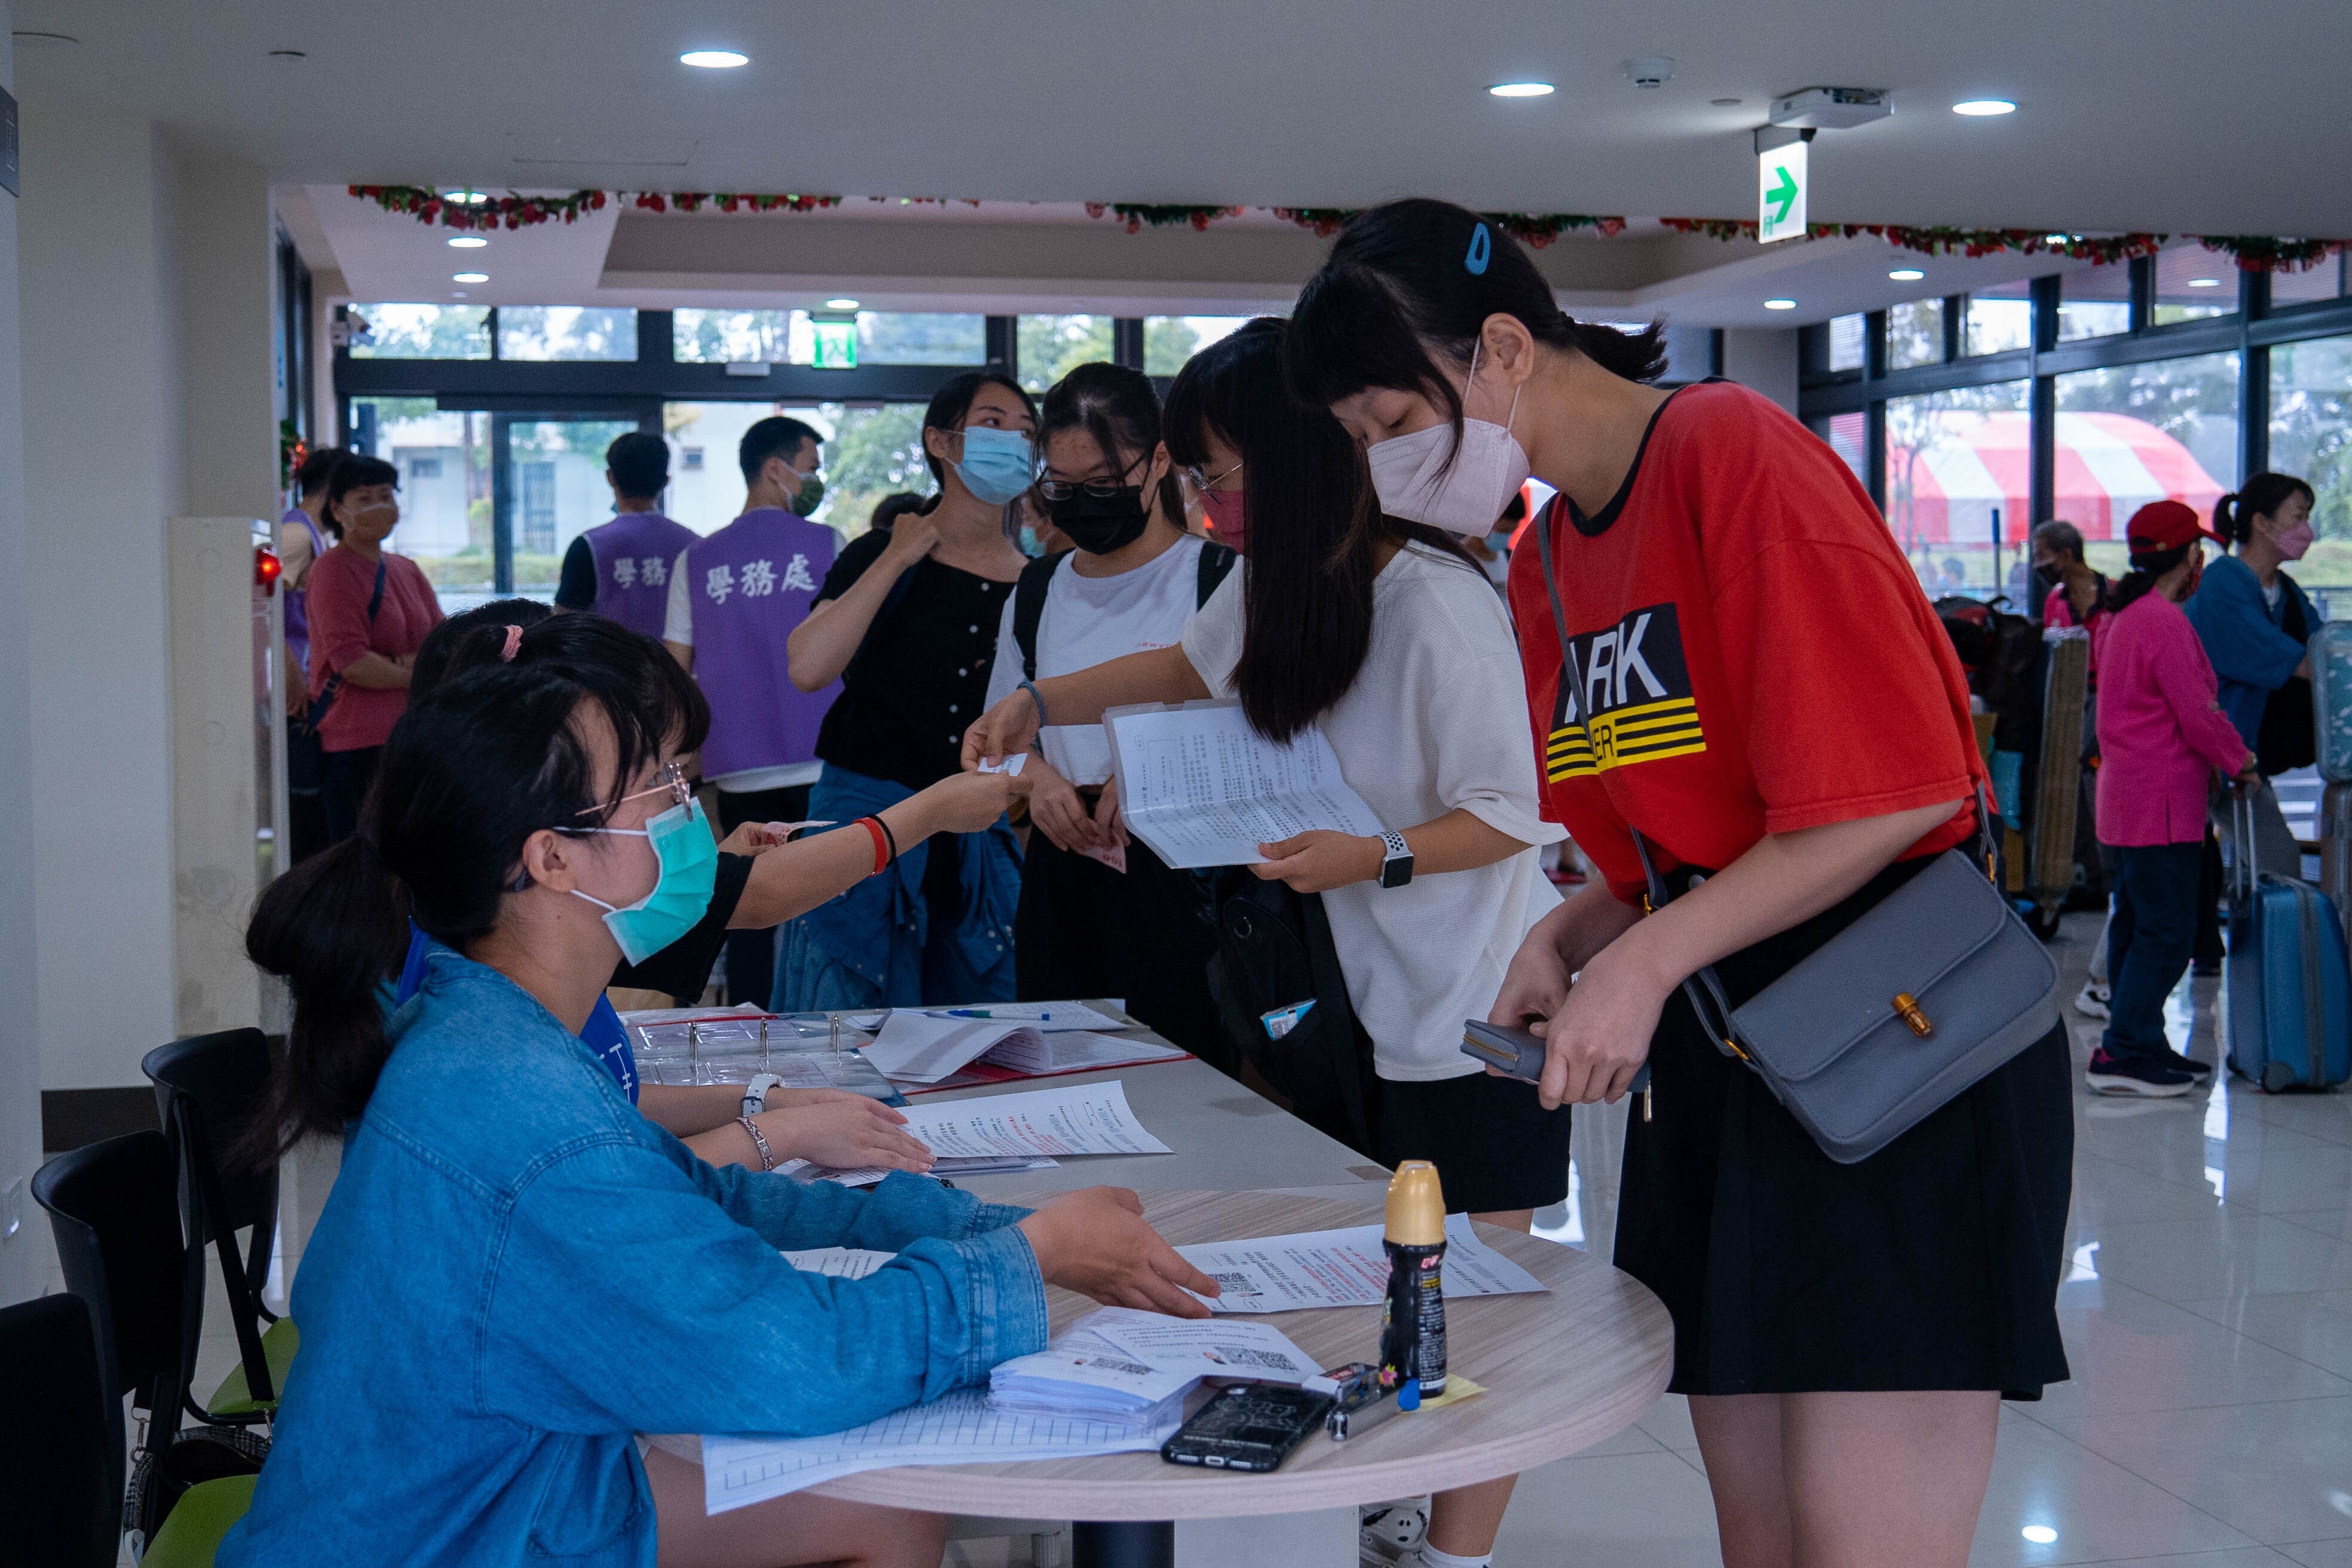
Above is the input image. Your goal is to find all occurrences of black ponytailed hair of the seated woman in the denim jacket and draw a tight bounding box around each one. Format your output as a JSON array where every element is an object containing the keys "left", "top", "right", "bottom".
[{"left": 244, "top": 616, "right": 708, "bottom": 1161}]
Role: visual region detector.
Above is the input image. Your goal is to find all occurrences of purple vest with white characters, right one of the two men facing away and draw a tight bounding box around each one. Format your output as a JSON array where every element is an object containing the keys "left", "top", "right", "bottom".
[{"left": 687, "top": 506, "right": 842, "bottom": 778}]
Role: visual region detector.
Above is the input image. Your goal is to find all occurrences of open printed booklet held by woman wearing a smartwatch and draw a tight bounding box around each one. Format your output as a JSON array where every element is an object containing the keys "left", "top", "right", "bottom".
[{"left": 1103, "top": 703, "right": 1380, "bottom": 870}]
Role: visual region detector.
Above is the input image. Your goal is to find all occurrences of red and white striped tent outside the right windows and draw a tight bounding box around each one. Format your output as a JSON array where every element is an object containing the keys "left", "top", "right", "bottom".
[{"left": 1886, "top": 411, "right": 2223, "bottom": 546}]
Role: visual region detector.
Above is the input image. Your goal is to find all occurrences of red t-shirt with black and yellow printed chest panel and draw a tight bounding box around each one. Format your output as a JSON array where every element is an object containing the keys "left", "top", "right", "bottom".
[{"left": 1510, "top": 383, "right": 1983, "bottom": 903}]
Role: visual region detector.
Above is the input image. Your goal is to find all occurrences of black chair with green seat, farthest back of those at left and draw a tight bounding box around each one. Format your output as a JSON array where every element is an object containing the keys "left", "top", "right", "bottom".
[{"left": 139, "top": 1030, "right": 301, "bottom": 1425}]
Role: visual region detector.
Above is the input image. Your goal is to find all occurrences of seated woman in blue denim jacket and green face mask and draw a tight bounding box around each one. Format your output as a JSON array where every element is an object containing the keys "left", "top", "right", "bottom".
[{"left": 219, "top": 639, "right": 1216, "bottom": 1568}]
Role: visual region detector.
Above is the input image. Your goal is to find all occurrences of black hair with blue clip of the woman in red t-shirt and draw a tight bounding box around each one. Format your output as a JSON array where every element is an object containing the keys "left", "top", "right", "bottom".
[{"left": 1284, "top": 197, "right": 1665, "bottom": 428}]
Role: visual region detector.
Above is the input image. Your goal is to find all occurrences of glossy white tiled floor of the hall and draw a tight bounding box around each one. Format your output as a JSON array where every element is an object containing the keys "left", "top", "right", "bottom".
[{"left": 32, "top": 917, "right": 2352, "bottom": 1568}]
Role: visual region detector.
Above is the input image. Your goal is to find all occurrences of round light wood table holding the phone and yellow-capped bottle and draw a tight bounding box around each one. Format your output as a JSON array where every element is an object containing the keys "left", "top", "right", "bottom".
[{"left": 811, "top": 1190, "right": 1674, "bottom": 1568}]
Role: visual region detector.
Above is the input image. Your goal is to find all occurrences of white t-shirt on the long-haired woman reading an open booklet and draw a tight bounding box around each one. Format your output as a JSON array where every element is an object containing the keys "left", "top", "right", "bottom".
[{"left": 1183, "top": 546, "right": 1566, "bottom": 1084}]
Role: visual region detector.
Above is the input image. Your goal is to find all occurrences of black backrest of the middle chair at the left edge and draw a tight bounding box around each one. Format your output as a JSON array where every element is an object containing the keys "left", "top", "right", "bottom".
[{"left": 33, "top": 1133, "right": 191, "bottom": 1495}]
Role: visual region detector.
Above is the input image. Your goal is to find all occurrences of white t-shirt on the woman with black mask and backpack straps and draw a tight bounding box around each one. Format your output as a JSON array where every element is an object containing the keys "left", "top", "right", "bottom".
[{"left": 988, "top": 534, "right": 1237, "bottom": 785}]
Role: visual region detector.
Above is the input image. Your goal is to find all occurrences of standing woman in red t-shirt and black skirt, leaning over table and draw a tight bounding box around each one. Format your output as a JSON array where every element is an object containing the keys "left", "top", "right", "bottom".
[{"left": 1287, "top": 200, "right": 2072, "bottom": 1568}]
